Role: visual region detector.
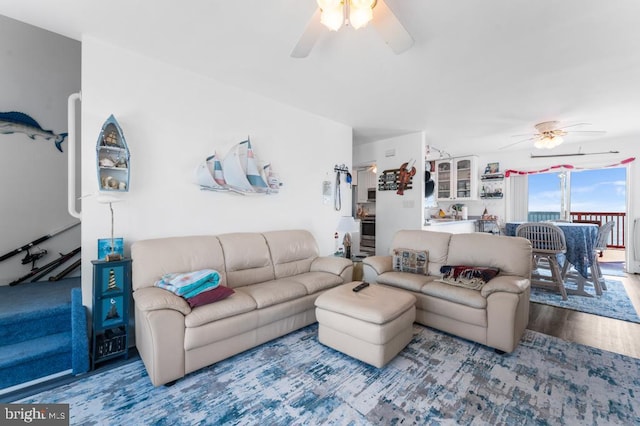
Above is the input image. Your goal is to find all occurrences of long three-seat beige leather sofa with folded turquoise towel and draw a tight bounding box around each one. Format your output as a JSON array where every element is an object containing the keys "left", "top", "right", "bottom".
[{"left": 131, "top": 230, "right": 353, "bottom": 386}]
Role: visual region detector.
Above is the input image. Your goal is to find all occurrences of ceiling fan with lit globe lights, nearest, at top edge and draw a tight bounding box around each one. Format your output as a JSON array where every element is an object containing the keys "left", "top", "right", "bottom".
[{"left": 291, "top": 0, "right": 413, "bottom": 58}]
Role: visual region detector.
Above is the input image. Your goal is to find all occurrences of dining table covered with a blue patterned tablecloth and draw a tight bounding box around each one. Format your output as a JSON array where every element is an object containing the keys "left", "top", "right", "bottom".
[{"left": 505, "top": 222, "right": 602, "bottom": 296}]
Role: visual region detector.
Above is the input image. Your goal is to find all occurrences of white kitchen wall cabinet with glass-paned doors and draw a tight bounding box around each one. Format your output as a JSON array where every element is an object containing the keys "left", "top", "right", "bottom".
[{"left": 436, "top": 156, "right": 478, "bottom": 201}]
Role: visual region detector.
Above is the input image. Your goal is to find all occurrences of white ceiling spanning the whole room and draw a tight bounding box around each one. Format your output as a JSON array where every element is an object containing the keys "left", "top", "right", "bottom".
[{"left": 0, "top": 0, "right": 640, "bottom": 155}]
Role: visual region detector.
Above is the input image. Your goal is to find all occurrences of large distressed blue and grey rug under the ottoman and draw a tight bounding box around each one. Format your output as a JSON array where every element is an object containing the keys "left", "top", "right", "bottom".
[{"left": 16, "top": 325, "right": 640, "bottom": 425}]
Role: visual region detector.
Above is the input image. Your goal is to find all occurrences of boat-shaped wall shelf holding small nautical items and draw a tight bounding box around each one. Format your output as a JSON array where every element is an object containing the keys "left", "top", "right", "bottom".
[{"left": 96, "top": 115, "right": 130, "bottom": 192}]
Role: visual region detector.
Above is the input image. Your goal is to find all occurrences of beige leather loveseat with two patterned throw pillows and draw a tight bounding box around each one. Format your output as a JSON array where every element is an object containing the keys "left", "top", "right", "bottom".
[{"left": 363, "top": 230, "right": 531, "bottom": 352}]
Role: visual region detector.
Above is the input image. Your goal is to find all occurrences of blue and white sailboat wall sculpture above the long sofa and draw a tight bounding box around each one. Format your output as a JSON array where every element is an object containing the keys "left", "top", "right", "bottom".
[{"left": 195, "top": 138, "right": 282, "bottom": 194}]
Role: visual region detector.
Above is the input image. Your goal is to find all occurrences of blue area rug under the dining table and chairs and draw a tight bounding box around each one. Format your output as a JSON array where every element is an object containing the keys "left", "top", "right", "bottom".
[{"left": 530, "top": 279, "right": 640, "bottom": 323}]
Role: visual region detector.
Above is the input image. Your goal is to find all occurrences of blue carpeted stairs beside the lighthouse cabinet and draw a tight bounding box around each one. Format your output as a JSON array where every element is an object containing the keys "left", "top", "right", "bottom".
[{"left": 0, "top": 278, "right": 88, "bottom": 389}]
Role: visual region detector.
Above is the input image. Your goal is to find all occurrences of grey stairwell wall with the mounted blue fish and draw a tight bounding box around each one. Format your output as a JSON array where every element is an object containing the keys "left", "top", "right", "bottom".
[{"left": 0, "top": 16, "right": 81, "bottom": 285}]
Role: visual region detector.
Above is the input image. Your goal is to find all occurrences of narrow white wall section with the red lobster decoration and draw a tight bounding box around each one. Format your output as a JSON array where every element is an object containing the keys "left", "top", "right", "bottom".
[{"left": 353, "top": 132, "right": 425, "bottom": 255}]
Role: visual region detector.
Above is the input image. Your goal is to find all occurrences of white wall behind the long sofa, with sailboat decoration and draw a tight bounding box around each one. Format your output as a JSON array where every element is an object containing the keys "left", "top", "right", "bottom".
[{"left": 82, "top": 38, "right": 352, "bottom": 305}]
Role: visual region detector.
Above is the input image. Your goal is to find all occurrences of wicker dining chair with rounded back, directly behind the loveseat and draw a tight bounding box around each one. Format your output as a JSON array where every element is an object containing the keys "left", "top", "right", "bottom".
[{"left": 516, "top": 222, "right": 567, "bottom": 300}]
